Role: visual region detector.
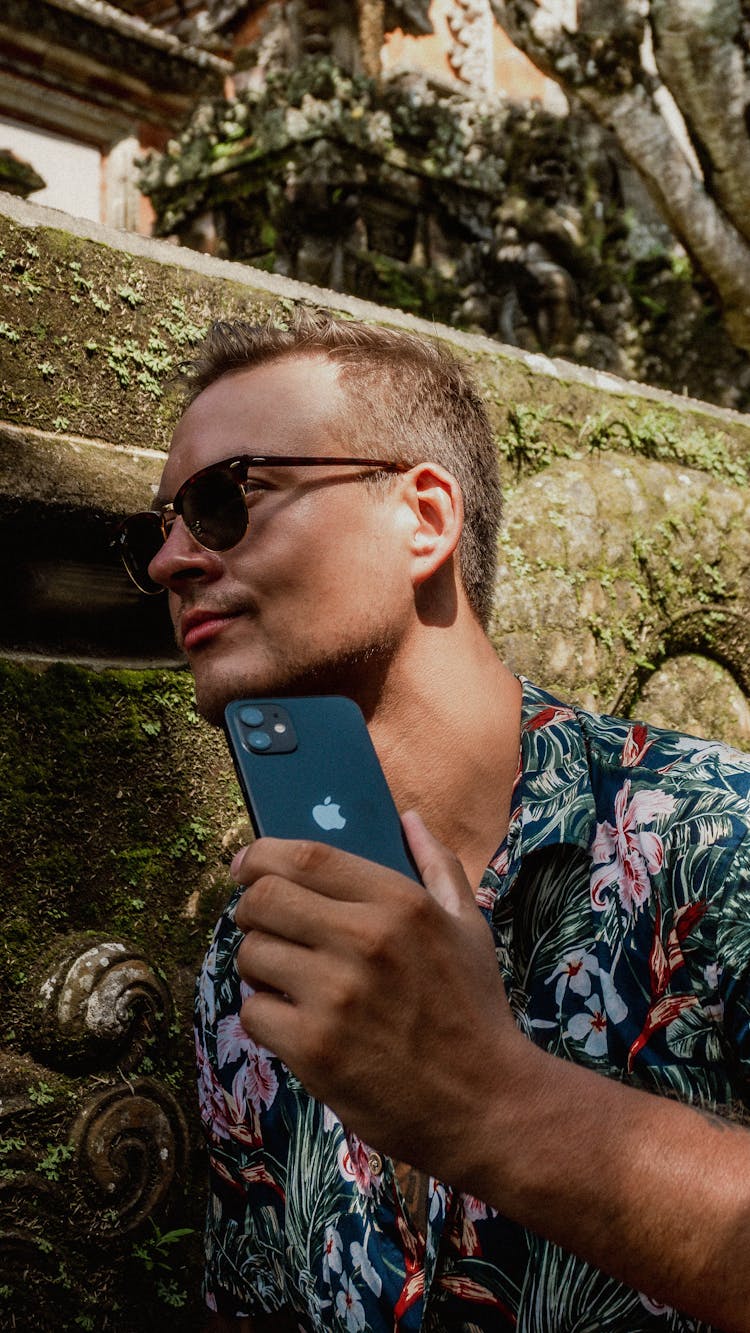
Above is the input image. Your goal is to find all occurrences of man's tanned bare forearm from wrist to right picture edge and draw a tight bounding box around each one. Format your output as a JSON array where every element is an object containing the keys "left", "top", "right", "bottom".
[{"left": 455, "top": 1038, "right": 750, "bottom": 1333}]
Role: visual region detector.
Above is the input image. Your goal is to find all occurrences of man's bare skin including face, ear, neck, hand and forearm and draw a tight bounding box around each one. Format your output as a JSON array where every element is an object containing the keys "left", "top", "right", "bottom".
[{"left": 151, "top": 359, "right": 750, "bottom": 1333}]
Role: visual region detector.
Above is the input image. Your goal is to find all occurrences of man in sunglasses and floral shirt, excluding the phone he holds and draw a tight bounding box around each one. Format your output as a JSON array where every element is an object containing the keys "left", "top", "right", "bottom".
[{"left": 117, "top": 316, "right": 750, "bottom": 1333}]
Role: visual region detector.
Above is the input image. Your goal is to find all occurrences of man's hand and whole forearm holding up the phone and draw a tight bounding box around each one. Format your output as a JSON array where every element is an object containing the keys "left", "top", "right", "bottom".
[{"left": 233, "top": 814, "right": 750, "bottom": 1333}]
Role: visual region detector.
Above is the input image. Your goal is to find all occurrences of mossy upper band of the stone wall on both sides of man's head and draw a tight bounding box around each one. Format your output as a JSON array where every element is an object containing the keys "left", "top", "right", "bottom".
[{"left": 0, "top": 205, "right": 750, "bottom": 481}]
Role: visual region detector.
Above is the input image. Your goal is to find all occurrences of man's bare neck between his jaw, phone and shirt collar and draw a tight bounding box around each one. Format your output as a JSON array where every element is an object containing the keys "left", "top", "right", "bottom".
[{"left": 369, "top": 625, "right": 521, "bottom": 888}]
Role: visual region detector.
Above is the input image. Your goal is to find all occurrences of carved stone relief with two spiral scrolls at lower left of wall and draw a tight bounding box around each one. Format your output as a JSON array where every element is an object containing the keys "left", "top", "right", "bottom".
[{"left": 0, "top": 936, "right": 189, "bottom": 1330}]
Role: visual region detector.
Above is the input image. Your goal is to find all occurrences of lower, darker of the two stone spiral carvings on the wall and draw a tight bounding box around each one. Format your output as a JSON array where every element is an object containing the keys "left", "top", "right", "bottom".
[{"left": 71, "top": 1078, "right": 188, "bottom": 1234}]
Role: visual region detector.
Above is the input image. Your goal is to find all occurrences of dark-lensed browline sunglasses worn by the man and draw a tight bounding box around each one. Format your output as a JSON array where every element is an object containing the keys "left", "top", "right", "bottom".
[{"left": 113, "top": 453, "right": 408, "bottom": 596}]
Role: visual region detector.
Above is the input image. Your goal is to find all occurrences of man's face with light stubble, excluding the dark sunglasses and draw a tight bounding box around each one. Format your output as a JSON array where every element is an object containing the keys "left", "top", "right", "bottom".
[{"left": 151, "top": 357, "right": 413, "bottom": 722}]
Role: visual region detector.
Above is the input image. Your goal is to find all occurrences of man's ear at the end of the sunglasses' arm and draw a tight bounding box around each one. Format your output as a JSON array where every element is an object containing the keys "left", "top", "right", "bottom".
[{"left": 404, "top": 463, "right": 464, "bottom": 588}]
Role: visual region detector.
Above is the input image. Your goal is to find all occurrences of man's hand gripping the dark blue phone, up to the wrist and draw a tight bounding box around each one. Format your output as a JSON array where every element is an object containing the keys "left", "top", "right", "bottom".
[{"left": 232, "top": 813, "right": 516, "bottom": 1178}]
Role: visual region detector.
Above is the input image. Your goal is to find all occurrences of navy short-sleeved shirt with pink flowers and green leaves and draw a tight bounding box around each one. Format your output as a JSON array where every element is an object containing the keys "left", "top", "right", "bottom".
[{"left": 196, "top": 681, "right": 750, "bottom": 1333}]
